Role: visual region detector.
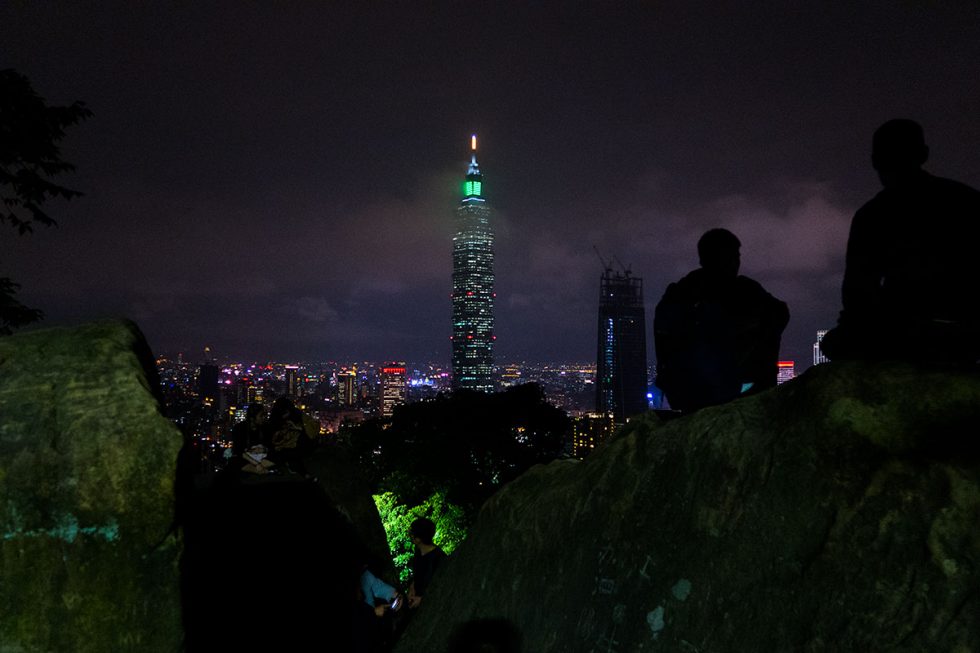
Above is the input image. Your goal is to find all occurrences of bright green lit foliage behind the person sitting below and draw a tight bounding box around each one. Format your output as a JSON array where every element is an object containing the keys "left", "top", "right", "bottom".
[{"left": 374, "top": 492, "right": 467, "bottom": 584}]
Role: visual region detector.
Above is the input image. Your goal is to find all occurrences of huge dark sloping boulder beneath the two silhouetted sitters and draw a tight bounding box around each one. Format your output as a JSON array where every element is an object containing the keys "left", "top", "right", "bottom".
[{"left": 397, "top": 363, "right": 980, "bottom": 653}]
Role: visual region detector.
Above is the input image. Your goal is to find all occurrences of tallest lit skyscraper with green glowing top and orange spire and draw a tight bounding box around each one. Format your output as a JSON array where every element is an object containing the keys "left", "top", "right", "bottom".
[{"left": 452, "top": 135, "right": 495, "bottom": 392}]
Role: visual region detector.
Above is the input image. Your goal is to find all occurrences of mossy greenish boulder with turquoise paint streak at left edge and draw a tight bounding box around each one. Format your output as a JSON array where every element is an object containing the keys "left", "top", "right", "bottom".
[{"left": 0, "top": 322, "right": 182, "bottom": 653}]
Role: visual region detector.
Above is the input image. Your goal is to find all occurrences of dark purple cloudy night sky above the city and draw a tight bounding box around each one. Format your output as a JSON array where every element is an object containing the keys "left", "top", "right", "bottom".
[{"left": 0, "top": 1, "right": 980, "bottom": 368}]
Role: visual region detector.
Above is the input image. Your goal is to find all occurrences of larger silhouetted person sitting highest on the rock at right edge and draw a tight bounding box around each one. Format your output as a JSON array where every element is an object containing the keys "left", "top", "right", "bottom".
[{"left": 821, "top": 120, "right": 980, "bottom": 365}]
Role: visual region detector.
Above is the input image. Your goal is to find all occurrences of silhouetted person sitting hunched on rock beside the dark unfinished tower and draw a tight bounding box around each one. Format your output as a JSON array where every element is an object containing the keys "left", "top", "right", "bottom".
[{"left": 653, "top": 229, "right": 789, "bottom": 412}]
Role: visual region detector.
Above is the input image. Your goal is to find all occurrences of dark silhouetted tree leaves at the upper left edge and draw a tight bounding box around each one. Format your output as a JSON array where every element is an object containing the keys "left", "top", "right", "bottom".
[{"left": 0, "top": 69, "right": 92, "bottom": 335}]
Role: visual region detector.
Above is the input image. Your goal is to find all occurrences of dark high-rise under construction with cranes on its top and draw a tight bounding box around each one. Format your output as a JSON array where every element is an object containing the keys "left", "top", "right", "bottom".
[{"left": 596, "top": 268, "right": 647, "bottom": 424}]
